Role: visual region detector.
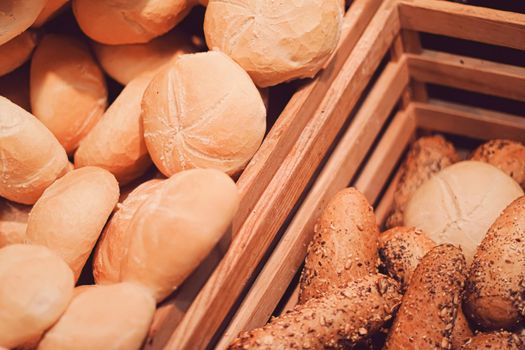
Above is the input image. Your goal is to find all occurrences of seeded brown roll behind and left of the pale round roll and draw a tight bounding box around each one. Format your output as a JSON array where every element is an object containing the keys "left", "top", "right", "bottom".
[{"left": 385, "top": 135, "right": 459, "bottom": 228}]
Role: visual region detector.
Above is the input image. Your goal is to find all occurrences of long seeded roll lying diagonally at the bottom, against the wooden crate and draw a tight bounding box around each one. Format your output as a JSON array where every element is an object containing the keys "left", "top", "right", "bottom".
[{"left": 229, "top": 274, "right": 401, "bottom": 350}]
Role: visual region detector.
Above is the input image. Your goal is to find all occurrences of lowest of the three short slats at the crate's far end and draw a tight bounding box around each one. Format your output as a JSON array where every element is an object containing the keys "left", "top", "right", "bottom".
[{"left": 412, "top": 100, "right": 525, "bottom": 142}]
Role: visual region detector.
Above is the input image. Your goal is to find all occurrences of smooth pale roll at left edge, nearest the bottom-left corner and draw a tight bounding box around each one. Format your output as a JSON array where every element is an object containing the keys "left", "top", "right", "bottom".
[{"left": 0, "top": 244, "right": 74, "bottom": 348}]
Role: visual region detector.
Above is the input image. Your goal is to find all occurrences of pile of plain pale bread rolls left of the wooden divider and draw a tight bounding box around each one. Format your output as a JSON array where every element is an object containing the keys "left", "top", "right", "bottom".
[{"left": 0, "top": 0, "right": 344, "bottom": 349}]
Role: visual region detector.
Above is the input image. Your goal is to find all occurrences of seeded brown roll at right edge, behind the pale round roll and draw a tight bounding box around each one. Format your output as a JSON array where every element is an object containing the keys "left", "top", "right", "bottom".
[{"left": 471, "top": 140, "right": 525, "bottom": 188}]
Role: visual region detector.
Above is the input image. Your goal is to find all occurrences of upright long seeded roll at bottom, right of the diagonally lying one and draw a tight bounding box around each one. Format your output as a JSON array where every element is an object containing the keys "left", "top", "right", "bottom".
[{"left": 385, "top": 244, "right": 466, "bottom": 350}]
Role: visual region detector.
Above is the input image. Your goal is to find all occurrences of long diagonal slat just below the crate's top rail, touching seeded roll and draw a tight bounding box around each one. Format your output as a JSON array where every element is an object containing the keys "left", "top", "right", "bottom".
[{"left": 217, "top": 61, "right": 409, "bottom": 350}]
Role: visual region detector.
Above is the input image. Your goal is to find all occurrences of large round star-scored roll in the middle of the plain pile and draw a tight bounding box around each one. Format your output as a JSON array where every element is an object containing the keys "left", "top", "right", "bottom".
[{"left": 142, "top": 52, "right": 266, "bottom": 176}]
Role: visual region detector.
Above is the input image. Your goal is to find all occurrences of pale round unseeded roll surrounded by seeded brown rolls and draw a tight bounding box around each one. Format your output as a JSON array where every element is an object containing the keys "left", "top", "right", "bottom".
[{"left": 404, "top": 161, "right": 523, "bottom": 263}]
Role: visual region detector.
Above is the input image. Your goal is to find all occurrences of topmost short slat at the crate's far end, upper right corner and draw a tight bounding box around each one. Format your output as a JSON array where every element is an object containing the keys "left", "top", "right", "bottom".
[{"left": 399, "top": 0, "right": 525, "bottom": 50}]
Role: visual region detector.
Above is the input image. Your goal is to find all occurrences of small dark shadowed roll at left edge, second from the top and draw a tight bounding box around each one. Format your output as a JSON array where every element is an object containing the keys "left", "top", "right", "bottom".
[{"left": 0, "top": 30, "right": 37, "bottom": 76}]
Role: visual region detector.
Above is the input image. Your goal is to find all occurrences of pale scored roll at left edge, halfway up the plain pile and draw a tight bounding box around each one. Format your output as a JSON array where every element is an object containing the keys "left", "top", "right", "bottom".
[{"left": 0, "top": 96, "right": 68, "bottom": 204}]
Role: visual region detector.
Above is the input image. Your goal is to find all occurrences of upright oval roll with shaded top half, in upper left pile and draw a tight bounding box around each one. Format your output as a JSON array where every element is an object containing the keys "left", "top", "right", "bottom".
[{"left": 30, "top": 34, "right": 108, "bottom": 154}]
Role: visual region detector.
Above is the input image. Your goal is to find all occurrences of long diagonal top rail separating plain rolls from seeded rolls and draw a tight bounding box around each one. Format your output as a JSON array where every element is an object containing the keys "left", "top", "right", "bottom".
[{"left": 166, "top": 1, "right": 399, "bottom": 349}]
